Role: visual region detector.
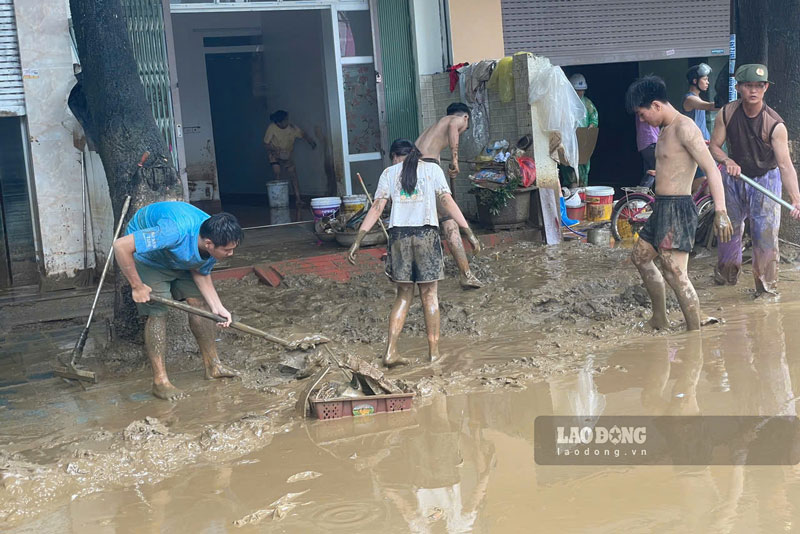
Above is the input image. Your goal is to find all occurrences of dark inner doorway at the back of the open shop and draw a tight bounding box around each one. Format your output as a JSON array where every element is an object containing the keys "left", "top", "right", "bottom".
[{"left": 206, "top": 52, "right": 270, "bottom": 226}]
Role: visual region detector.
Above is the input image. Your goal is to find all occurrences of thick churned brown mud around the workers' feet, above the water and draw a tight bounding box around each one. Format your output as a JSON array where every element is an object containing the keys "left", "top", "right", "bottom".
[{"left": 0, "top": 242, "right": 724, "bottom": 520}]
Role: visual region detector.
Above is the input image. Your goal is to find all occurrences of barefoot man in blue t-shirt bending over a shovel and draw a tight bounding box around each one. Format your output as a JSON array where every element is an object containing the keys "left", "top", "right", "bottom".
[{"left": 114, "top": 202, "right": 243, "bottom": 400}]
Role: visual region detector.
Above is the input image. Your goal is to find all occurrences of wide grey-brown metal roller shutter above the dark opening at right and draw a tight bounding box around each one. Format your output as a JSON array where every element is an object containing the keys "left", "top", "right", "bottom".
[{"left": 502, "top": 0, "right": 730, "bottom": 65}]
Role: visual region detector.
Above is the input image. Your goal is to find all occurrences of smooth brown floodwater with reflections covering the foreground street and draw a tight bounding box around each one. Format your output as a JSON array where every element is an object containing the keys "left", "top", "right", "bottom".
[{"left": 9, "top": 294, "right": 800, "bottom": 534}]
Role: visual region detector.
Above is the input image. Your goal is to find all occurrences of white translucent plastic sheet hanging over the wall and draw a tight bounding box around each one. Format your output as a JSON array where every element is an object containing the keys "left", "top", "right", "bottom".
[{"left": 528, "top": 60, "right": 586, "bottom": 175}]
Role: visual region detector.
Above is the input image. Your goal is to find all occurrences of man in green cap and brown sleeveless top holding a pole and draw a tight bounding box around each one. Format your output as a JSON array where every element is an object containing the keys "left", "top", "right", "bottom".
[{"left": 709, "top": 64, "right": 800, "bottom": 296}]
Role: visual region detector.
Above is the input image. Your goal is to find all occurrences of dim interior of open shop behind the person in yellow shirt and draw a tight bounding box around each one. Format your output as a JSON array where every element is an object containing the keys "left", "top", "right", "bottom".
[{"left": 173, "top": 10, "right": 338, "bottom": 226}]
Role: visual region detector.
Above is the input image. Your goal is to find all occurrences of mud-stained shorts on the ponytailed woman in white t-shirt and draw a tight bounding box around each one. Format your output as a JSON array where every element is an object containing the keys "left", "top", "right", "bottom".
[{"left": 386, "top": 226, "right": 444, "bottom": 283}]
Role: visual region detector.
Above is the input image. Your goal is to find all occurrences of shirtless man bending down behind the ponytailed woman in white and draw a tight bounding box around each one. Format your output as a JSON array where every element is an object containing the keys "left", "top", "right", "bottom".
[{"left": 414, "top": 102, "right": 483, "bottom": 289}]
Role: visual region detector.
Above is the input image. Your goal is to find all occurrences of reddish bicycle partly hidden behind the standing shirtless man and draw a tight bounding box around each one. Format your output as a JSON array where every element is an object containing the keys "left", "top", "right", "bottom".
[{"left": 611, "top": 180, "right": 714, "bottom": 250}]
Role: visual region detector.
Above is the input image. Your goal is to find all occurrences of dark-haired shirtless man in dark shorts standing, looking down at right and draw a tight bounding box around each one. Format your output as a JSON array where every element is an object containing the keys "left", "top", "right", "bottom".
[{"left": 625, "top": 76, "right": 733, "bottom": 330}]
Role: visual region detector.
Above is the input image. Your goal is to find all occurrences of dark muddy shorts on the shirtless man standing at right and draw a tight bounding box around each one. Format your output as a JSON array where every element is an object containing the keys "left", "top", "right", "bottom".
[{"left": 639, "top": 195, "right": 697, "bottom": 252}]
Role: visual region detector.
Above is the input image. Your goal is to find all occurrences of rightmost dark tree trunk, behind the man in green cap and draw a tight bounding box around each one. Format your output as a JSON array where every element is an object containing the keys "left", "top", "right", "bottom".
[{"left": 767, "top": 0, "right": 800, "bottom": 252}]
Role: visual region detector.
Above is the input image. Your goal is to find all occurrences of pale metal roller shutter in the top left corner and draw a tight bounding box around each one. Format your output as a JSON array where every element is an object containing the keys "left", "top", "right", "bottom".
[{"left": 0, "top": 0, "right": 25, "bottom": 117}]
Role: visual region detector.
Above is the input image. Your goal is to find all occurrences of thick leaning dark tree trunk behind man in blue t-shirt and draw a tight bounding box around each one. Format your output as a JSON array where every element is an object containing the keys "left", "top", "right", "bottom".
[{"left": 70, "top": 0, "right": 183, "bottom": 339}]
